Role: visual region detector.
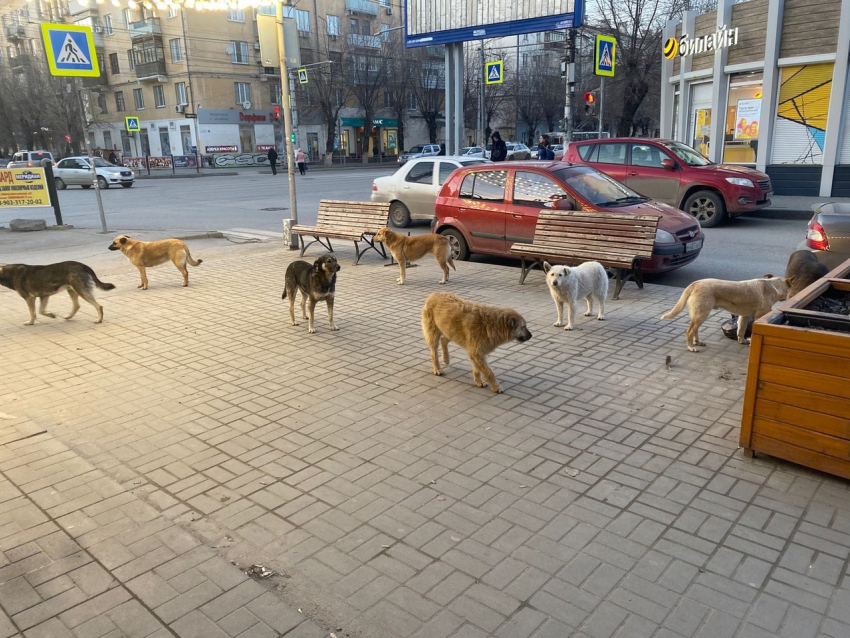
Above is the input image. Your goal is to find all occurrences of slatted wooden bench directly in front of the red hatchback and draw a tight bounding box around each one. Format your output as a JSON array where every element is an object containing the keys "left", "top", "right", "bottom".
[{"left": 511, "top": 210, "right": 661, "bottom": 299}]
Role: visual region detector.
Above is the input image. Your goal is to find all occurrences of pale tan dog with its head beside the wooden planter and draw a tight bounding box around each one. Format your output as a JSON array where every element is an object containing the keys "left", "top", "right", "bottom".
[{"left": 661, "top": 276, "right": 794, "bottom": 352}]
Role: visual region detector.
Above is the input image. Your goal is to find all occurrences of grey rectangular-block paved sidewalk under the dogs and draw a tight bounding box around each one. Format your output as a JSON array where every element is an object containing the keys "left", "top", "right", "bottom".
[{"left": 0, "top": 241, "right": 850, "bottom": 638}]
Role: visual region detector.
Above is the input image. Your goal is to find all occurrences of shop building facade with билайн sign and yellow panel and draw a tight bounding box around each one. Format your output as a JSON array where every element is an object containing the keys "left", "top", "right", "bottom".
[{"left": 661, "top": 0, "right": 850, "bottom": 197}]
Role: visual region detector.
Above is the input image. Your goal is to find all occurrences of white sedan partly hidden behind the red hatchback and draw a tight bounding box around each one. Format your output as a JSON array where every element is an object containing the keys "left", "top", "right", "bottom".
[{"left": 372, "top": 155, "right": 489, "bottom": 228}]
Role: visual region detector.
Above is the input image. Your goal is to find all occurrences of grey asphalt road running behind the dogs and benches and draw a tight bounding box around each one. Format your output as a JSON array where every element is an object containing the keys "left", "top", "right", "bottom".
[{"left": 0, "top": 167, "right": 806, "bottom": 286}]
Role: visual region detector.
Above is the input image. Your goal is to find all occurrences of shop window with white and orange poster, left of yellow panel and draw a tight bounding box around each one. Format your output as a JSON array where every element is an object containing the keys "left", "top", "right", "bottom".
[{"left": 723, "top": 73, "right": 762, "bottom": 164}]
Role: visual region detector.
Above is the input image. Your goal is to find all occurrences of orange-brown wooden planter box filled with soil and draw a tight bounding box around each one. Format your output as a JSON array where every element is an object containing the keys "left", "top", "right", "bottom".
[{"left": 740, "top": 260, "right": 850, "bottom": 478}]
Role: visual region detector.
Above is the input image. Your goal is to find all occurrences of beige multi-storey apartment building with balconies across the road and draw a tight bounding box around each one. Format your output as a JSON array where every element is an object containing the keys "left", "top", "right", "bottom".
[{"left": 0, "top": 0, "right": 444, "bottom": 160}]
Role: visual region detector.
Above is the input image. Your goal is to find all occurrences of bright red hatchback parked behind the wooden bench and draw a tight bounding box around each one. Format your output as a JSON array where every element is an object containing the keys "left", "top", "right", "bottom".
[{"left": 431, "top": 162, "right": 704, "bottom": 273}]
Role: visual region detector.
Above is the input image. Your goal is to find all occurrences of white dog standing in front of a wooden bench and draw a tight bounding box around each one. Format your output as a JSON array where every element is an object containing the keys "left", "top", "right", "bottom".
[{"left": 543, "top": 261, "right": 608, "bottom": 330}]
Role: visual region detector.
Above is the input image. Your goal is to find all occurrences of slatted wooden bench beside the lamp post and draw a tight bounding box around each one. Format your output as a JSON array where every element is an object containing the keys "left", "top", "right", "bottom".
[{"left": 292, "top": 199, "right": 390, "bottom": 266}]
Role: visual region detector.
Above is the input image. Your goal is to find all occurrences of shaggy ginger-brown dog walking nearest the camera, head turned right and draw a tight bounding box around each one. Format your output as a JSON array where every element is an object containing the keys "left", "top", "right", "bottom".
[{"left": 422, "top": 292, "right": 531, "bottom": 394}]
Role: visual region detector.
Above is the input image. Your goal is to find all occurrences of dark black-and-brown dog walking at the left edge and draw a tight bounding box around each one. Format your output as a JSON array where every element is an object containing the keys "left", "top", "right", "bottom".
[{"left": 0, "top": 261, "right": 115, "bottom": 326}]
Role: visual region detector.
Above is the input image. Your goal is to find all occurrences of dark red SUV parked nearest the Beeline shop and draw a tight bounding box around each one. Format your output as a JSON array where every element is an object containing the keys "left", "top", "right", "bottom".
[{"left": 565, "top": 137, "right": 773, "bottom": 228}]
